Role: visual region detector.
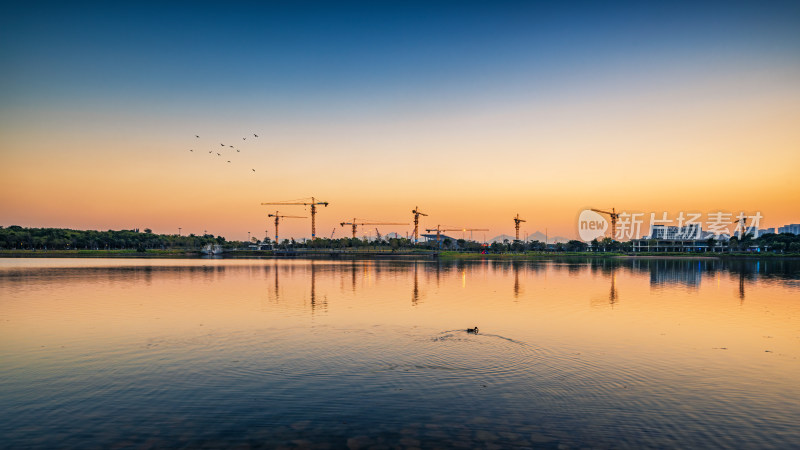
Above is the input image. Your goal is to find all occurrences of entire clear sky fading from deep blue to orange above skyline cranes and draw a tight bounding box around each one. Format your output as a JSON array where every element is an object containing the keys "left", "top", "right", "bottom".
[{"left": 0, "top": 1, "right": 800, "bottom": 240}]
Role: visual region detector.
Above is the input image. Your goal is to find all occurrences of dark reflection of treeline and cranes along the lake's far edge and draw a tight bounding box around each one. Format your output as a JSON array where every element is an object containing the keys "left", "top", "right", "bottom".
[{"left": 0, "top": 258, "right": 800, "bottom": 310}]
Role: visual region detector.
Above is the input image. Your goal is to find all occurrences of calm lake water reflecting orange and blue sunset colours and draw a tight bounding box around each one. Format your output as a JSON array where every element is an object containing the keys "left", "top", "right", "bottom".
[{"left": 0, "top": 259, "right": 800, "bottom": 449}]
